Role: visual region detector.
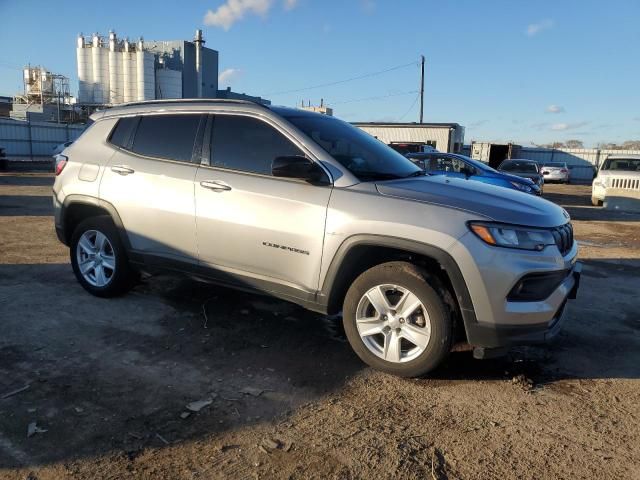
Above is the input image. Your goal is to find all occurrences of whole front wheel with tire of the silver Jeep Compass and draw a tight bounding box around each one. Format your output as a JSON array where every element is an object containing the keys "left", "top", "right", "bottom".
[{"left": 343, "top": 262, "right": 453, "bottom": 377}]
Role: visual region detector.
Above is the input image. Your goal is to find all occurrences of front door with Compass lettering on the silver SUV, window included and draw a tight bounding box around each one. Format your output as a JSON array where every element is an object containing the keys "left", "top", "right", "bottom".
[{"left": 195, "top": 114, "right": 331, "bottom": 295}]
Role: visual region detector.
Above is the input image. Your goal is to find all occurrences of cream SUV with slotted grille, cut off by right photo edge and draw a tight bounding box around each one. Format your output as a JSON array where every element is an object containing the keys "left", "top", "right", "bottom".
[{"left": 591, "top": 155, "right": 640, "bottom": 206}]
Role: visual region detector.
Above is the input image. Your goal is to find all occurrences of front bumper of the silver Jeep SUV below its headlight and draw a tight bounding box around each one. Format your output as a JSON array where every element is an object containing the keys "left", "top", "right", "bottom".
[{"left": 451, "top": 234, "right": 581, "bottom": 348}]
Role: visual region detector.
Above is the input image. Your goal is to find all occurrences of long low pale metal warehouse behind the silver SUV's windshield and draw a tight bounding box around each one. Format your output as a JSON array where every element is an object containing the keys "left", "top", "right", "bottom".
[{"left": 354, "top": 122, "right": 464, "bottom": 153}]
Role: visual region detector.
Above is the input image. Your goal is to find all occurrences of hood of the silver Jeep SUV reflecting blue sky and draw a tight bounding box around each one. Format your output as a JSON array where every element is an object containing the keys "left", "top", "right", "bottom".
[{"left": 376, "top": 175, "right": 569, "bottom": 227}]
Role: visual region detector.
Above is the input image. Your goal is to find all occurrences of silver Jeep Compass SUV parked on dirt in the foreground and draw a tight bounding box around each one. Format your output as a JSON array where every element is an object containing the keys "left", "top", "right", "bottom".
[{"left": 53, "top": 100, "right": 580, "bottom": 376}]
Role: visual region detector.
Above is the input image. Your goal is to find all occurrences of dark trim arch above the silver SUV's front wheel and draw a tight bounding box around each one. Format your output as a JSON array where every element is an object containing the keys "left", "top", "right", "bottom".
[{"left": 321, "top": 235, "right": 477, "bottom": 342}]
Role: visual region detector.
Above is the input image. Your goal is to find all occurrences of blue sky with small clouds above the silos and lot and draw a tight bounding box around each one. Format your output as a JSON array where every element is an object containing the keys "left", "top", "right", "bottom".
[{"left": 0, "top": 0, "right": 640, "bottom": 145}]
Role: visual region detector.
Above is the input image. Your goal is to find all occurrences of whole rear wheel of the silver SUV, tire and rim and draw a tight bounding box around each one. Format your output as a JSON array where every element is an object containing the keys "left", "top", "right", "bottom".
[{"left": 70, "top": 216, "right": 134, "bottom": 297}]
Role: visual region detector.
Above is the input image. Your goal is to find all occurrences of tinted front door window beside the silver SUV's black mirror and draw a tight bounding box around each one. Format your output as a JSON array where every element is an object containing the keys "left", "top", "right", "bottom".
[{"left": 211, "top": 115, "right": 303, "bottom": 175}]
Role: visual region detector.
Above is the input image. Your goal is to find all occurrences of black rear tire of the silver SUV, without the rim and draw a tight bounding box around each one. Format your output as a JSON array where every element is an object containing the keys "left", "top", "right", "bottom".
[{"left": 69, "top": 216, "right": 135, "bottom": 297}]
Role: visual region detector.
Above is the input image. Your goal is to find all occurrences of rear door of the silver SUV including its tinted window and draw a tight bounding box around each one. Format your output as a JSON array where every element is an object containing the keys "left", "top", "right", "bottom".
[{"left": 100, "top": 114, "right": 205, "bottom": 263}]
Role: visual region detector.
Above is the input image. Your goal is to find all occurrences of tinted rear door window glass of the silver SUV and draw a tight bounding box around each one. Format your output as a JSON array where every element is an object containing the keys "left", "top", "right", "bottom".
[{"left": 131, "top": 115, "right": 201, "bottom": 162}]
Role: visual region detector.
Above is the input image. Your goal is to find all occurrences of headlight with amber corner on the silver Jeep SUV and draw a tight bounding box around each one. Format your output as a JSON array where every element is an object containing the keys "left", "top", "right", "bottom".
[{"left": 468, "top": 222, "right": 556, "bottom": 252}]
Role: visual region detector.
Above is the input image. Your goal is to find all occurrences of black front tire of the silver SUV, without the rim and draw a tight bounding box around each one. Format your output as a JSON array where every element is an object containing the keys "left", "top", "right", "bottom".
[{"left": 342, "top": 262, "right": 453, "bottom": 377}]
